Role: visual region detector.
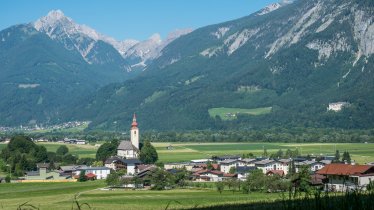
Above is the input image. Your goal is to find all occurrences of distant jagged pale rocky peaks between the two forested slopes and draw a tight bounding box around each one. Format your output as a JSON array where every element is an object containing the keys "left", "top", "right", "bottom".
[{"left": 33, "top": 10, "right": 192, "bottom": 71}]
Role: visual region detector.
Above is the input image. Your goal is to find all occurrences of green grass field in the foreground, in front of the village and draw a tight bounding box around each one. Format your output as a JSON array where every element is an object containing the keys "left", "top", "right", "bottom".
[{"left": 0, "top": 181, "right": 280, "bottom": 210}]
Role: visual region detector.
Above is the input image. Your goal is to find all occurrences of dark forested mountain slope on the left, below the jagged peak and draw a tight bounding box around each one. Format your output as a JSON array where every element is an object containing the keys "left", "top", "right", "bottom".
[{"left": 0, "top": 25, "right": 126, "bottom": 125}]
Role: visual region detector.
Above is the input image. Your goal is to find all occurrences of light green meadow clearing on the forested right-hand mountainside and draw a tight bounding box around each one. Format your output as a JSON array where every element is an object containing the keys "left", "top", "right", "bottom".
[{"left": 209, "top": 107, "right": 272, "bottom": 120}]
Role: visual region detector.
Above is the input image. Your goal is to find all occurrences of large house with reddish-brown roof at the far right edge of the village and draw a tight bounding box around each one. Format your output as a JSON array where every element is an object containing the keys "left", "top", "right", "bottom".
[{"left": 316, "top": 164, "right": 374, "bottom": 192}]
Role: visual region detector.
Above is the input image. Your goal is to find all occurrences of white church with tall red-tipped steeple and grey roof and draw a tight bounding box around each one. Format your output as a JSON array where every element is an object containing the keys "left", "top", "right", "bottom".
[{"left": 117, "top": 113, "right": 140, "bottom": 159}]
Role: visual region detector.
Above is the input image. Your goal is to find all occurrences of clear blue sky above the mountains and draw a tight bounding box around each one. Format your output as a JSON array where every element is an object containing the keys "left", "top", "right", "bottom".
[{"left": 0, "top": 0, "right": 277, "bottom": 40}]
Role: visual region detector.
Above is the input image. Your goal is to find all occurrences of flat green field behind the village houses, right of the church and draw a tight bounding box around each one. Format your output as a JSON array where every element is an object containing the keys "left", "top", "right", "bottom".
[{"left": 153, "top": 143, "right": 374, "bottom": 164}]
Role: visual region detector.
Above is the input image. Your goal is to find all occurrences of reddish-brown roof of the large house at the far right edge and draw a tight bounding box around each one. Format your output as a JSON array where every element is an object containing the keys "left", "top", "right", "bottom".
[{"left": 316, "top": 164, "right": 374, "bottom": 175}]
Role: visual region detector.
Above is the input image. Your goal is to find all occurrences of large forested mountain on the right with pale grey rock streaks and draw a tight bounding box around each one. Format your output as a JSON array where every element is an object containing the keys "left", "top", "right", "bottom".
[{"left": 72, "top": 0, "right": 374, "bottom": 129}]
